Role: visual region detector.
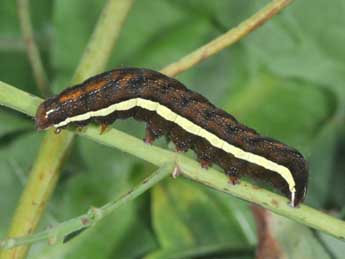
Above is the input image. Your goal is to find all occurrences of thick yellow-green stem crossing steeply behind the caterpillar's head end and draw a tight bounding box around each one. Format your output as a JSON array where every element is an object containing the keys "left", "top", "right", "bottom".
[{"left": 0, "top": 0, "right": 132, "bottom": 259}]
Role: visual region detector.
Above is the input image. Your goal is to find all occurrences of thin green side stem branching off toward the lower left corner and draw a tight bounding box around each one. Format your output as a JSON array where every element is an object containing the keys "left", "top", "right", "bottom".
[{"left": 0, "top": 163, "right": 174, "bottom": 249}]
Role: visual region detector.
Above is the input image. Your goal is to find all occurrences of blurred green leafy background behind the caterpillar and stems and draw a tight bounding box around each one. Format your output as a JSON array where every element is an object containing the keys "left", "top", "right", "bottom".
[{"left": 0, "top": 0, "right": 345, "bottom": 258}]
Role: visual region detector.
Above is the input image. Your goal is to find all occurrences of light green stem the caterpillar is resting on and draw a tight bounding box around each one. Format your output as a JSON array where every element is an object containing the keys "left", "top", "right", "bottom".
[{"left": 0, "top": 82, "right": 345, "bottom": 239}]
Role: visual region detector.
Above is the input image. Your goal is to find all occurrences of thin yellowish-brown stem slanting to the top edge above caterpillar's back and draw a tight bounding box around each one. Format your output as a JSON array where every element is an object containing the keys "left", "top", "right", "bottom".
[{"left": 161, "top": 0, "right": 292, "bottom": 76}]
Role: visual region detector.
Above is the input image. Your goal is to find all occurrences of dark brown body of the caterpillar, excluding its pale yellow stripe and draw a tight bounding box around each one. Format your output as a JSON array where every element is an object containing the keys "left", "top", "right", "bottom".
[{"left": 36, "top": 68, "right": 308, "bottom": 205}]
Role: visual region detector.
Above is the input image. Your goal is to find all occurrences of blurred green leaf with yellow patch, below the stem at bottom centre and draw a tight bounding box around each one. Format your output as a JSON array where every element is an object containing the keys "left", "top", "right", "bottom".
[{"left": 152, "top": 178, "right": 255, "bottom": 257}]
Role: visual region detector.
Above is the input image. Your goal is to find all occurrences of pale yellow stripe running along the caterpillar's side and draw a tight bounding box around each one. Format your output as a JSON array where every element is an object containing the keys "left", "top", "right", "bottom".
[{"left": 54, "top": 98, "right": 296, "bottom": 197}]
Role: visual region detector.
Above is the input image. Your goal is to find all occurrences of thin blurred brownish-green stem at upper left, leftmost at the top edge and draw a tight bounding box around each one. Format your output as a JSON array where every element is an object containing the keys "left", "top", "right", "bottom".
[{"left": 17, "top": 0, "right": 50, "bottom": 96}]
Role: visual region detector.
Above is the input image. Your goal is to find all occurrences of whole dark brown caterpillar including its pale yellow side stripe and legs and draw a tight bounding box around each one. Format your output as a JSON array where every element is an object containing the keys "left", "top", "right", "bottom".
[{"left": 35, "top": 68, "right": 308, "bottom": 207}]
